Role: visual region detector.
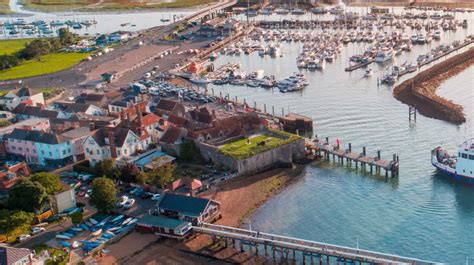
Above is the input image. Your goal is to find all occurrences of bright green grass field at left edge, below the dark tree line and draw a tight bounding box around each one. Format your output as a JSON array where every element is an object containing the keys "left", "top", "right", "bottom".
[{"left": 0, "top": 52, "right": 90, "bottom": 80}]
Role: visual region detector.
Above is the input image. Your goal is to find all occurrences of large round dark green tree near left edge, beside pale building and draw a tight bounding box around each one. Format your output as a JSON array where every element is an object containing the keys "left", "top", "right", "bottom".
[{"left": 7, "top": 179, "right": 48, "bottom": 212}]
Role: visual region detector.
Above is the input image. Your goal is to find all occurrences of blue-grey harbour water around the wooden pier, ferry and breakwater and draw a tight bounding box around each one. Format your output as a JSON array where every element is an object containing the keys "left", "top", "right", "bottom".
[{"left": 212, "top": 7, "right": 474, "bottom": 264}]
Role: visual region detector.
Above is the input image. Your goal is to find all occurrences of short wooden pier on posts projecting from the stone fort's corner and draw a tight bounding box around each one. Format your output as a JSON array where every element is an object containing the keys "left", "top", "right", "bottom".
[{"left": 306, "top": 138, "right": 399, "bottom": 177}]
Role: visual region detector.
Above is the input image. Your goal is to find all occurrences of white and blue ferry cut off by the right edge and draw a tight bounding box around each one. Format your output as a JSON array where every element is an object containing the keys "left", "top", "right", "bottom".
[{"left": 431, "top": 138, "right": 474, "bottom": 184}]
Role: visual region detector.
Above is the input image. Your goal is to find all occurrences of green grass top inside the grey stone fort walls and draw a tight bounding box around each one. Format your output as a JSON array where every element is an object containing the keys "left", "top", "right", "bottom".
[{"left": 219, "top": 131, "right": 300, "bottom": 159}]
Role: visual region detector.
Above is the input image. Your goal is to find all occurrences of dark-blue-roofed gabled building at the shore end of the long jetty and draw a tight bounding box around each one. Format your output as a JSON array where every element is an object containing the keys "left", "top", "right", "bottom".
[{"left": 158, "top": 193, "right": 220, "bottom": 225}]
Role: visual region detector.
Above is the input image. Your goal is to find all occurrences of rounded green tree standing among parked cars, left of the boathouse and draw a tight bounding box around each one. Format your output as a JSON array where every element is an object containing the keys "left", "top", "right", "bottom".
[{"left": 90, "top": 176, "right": 117, "bottom": 212}]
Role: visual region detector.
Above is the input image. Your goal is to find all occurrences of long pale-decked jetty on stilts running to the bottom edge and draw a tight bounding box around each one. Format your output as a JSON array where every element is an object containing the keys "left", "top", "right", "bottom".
[{"left": 192, "top": 223, "right": 437, "bottom": 264}]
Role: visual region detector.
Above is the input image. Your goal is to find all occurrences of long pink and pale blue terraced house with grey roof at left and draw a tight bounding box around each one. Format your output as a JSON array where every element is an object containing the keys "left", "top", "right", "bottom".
[{"left": 4, "top": 129, "right": 74, "bottom": 166}]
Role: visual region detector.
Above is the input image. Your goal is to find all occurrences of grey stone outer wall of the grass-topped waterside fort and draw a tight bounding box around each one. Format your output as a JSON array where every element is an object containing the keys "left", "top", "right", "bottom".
[{"left": 197, "top": 139, "right": 305, "bottom": 175}]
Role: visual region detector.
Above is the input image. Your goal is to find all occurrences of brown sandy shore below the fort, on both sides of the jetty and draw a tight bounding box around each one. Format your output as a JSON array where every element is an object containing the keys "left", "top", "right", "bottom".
[{"left": 97, "top": 165, "right": 304, "bottom": 264}]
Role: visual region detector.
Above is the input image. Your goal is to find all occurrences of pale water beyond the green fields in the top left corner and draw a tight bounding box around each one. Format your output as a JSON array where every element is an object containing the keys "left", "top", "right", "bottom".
[{"left": 0, "top": 0, "right": 195, "bottom": 38}]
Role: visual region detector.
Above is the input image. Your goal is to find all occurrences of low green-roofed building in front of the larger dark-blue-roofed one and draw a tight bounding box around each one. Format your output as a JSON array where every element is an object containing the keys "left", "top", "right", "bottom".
[{"left": 135, "top": 214, "right": 192, "bottom": 239}]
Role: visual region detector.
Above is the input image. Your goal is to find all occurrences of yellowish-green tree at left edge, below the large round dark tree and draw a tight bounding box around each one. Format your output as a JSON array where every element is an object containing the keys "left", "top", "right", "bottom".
[{"left": 0, "top": 210, "right": 34, "bottom": 240}]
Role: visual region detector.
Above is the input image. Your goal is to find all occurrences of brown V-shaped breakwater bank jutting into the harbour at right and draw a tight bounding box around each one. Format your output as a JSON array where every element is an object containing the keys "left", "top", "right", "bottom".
[{"left": 393, "top": 48, "right": 474, "bottom": 124}]
